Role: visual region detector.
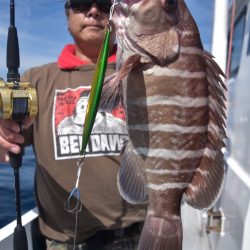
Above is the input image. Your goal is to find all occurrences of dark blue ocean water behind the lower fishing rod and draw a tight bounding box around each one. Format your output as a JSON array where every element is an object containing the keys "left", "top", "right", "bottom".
[{"left": 0, "top": 147, "right": 36, "bottom": 228}]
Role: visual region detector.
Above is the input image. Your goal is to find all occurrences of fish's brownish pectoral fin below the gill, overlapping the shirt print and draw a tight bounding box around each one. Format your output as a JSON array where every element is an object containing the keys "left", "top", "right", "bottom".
[{"left": 99, "top": 55, "right": 141, "bottom": 112}]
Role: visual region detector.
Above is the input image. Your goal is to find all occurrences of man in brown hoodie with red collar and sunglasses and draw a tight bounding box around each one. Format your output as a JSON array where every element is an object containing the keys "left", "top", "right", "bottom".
[{"left": 0, "top": 0, "right": 145, "bottom": 250}]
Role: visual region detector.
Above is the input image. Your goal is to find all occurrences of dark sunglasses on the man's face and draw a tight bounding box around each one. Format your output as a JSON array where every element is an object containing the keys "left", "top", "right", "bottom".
[{"left": 65, "top": 0, "right": 112, "bottom": 14}]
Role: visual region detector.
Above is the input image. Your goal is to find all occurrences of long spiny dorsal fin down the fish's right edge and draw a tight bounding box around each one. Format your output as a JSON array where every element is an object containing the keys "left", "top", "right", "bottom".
[{"left": 185, "top": 52, "right": 226, "bottom": 209}]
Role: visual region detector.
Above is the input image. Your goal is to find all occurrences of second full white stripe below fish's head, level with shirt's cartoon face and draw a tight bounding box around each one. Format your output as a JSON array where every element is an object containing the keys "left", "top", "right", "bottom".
[{"left": 129, "top": 95, "right": 208, "bottom": 108}]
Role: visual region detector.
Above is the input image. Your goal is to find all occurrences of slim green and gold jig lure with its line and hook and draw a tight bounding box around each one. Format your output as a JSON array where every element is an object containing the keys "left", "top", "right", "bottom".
[{"left": 64, "top": 0, "right": 117, "bottom": 250}]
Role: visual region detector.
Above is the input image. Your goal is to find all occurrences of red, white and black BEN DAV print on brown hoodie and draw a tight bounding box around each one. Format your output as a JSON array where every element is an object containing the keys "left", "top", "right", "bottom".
[{"left": 54, "top": 87, "right": 127, "bottom": 159}]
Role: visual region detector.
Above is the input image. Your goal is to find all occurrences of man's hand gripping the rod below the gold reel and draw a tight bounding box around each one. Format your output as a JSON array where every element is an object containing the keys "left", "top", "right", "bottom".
[{"left": 0, "top": 118, "right": 32, "bottom": 163}]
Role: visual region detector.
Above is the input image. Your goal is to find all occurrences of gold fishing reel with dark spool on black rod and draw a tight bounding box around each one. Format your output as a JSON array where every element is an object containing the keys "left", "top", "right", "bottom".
[{"left": 0, "top": 78, "right": 38, "bottom": 121}]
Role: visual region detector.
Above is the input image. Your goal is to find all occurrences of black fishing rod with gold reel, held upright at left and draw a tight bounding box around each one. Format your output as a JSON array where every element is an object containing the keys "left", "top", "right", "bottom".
[{"left": 0, "top": 0, "right": 37, "bottom": 250}]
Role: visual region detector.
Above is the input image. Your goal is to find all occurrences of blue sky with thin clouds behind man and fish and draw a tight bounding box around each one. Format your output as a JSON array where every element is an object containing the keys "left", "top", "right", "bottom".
[{"left": 0, "top": 0, "right": 213, "bottom": 79}]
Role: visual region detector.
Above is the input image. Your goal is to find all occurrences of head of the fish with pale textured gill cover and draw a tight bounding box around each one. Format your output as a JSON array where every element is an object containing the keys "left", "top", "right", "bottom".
[{"left": 115, "top": 0, "right": 201, "bottom": 66}]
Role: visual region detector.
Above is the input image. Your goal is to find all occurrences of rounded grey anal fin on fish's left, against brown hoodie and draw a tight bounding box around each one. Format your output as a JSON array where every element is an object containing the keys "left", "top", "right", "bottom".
[{"left": 117, "top": 140, "right": 148, "bottom": 204}]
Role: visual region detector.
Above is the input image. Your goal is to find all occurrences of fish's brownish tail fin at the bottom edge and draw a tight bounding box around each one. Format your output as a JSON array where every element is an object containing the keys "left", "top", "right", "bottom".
[{"left": 138, "top": 216, "right": 182, "bottom": 250}]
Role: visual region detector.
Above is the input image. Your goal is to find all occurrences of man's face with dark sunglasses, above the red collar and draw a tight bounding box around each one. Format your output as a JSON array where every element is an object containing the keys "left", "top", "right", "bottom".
[{"left": 67, "top": 0, "right": 111, "bottom": 46}]
